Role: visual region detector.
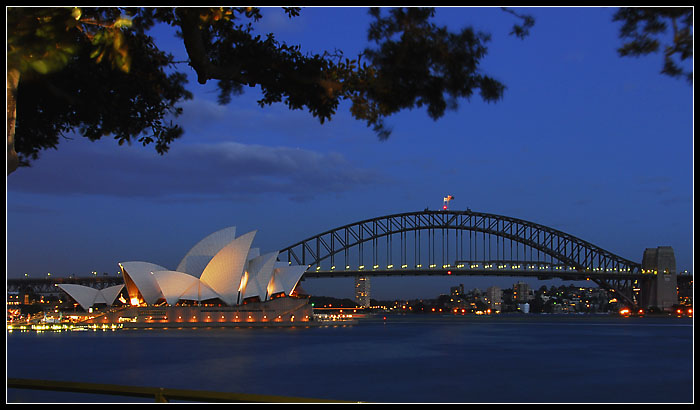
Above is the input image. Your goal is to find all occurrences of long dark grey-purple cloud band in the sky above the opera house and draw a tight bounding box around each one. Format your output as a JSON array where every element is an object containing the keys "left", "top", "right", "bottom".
[{"left": 8, "top": 142, "right": 383, "bottom": 201}]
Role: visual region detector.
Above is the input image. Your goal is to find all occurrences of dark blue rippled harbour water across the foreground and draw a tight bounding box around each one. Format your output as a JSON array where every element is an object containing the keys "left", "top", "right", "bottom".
[{"left": 6, "top": 315, "right": 694, "bottom": 403}]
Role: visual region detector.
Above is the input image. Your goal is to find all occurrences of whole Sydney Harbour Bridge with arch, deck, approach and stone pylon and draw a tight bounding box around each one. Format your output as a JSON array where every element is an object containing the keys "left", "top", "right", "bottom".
[{"left": 8, "top": 209, "right": 692, "bottom": 308}]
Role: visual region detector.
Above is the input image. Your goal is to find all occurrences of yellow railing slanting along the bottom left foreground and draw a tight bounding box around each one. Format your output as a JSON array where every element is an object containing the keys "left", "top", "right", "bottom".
[{"left": 7, "top": 378, "right": 356, "bottom": 403}]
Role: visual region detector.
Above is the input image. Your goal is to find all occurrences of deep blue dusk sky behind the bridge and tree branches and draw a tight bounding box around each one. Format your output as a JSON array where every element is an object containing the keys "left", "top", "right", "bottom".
[{"left": 7, "top": 8, "right": 694, "bottom": 299}]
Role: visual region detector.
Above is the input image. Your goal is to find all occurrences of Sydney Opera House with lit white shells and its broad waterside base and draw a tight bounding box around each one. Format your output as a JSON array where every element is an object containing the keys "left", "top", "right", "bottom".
[{"left": 58, "top": 227, "right": 312, "bottom": 327}]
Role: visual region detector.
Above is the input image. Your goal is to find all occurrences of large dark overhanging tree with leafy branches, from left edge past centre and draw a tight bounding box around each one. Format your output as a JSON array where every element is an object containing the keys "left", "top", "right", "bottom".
[{"left": 7, "top": 7, "right": 534, "bottom": 173}]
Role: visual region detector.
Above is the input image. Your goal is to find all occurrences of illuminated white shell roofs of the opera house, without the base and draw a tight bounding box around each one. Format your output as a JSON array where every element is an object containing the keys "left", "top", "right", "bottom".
[{"left": 61, "top": 226, "right": 308, "bottom": 309}]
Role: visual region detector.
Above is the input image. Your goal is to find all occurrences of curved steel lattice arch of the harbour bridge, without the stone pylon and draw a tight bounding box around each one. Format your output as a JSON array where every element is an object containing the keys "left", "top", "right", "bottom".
[{"left": 279, "top": 210, "right": 641, "bottom": 301}]
